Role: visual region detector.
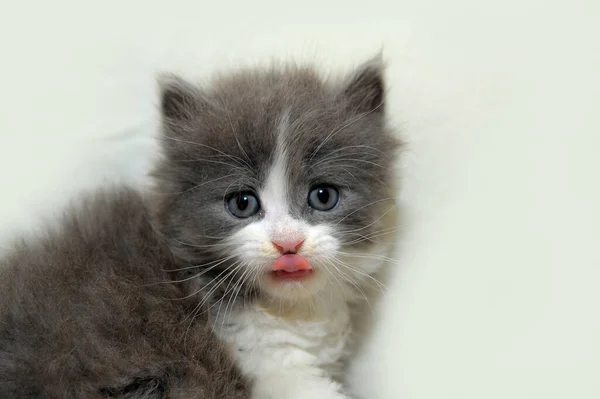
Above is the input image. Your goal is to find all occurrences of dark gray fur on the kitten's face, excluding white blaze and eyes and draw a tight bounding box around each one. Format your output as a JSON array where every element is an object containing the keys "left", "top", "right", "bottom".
[{"left": 153, "top": 60, "right": 399, "bottom": 295}]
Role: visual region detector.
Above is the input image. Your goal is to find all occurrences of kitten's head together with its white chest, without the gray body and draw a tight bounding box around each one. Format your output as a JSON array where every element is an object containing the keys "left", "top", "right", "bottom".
[{"left": 152, "top": 59, "right": 398, "bottom": 399}]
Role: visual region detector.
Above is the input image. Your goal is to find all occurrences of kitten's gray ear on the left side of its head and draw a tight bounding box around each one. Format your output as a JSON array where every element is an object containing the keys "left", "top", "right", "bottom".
[{"left": 158, "top": 75, "right": 203, "bottom": 121}]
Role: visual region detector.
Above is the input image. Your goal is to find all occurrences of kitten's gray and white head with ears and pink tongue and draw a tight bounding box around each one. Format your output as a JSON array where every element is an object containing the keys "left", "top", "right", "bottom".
[{"left": 155, "top": 60, "right": 398, "bottom": 300}]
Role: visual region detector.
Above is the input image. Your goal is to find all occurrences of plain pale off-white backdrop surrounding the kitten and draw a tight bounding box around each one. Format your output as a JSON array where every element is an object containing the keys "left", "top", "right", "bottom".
[{"left": 0, "top": 0, "right": 600, "bottom": 399}]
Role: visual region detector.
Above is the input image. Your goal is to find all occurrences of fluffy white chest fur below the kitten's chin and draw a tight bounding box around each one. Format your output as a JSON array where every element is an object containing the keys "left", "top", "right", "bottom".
[{"left": 214, "top": 295, "right": 351, "bottom": 399}]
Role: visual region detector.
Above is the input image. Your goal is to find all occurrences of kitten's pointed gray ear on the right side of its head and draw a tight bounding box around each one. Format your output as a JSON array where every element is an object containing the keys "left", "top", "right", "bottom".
[{"left": 343, "top": 54, "right": 385, "bottom": 113}]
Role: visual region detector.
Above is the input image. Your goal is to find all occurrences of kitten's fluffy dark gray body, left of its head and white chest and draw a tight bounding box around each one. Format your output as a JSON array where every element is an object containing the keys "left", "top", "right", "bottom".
[{"left": 0, "top": 189, "right": 248, "bottom": 399}]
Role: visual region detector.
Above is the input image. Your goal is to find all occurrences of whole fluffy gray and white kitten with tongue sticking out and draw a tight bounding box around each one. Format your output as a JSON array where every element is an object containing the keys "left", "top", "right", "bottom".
[{"left": 0, "top": 57, "right": 398, "bottom": 399}]
